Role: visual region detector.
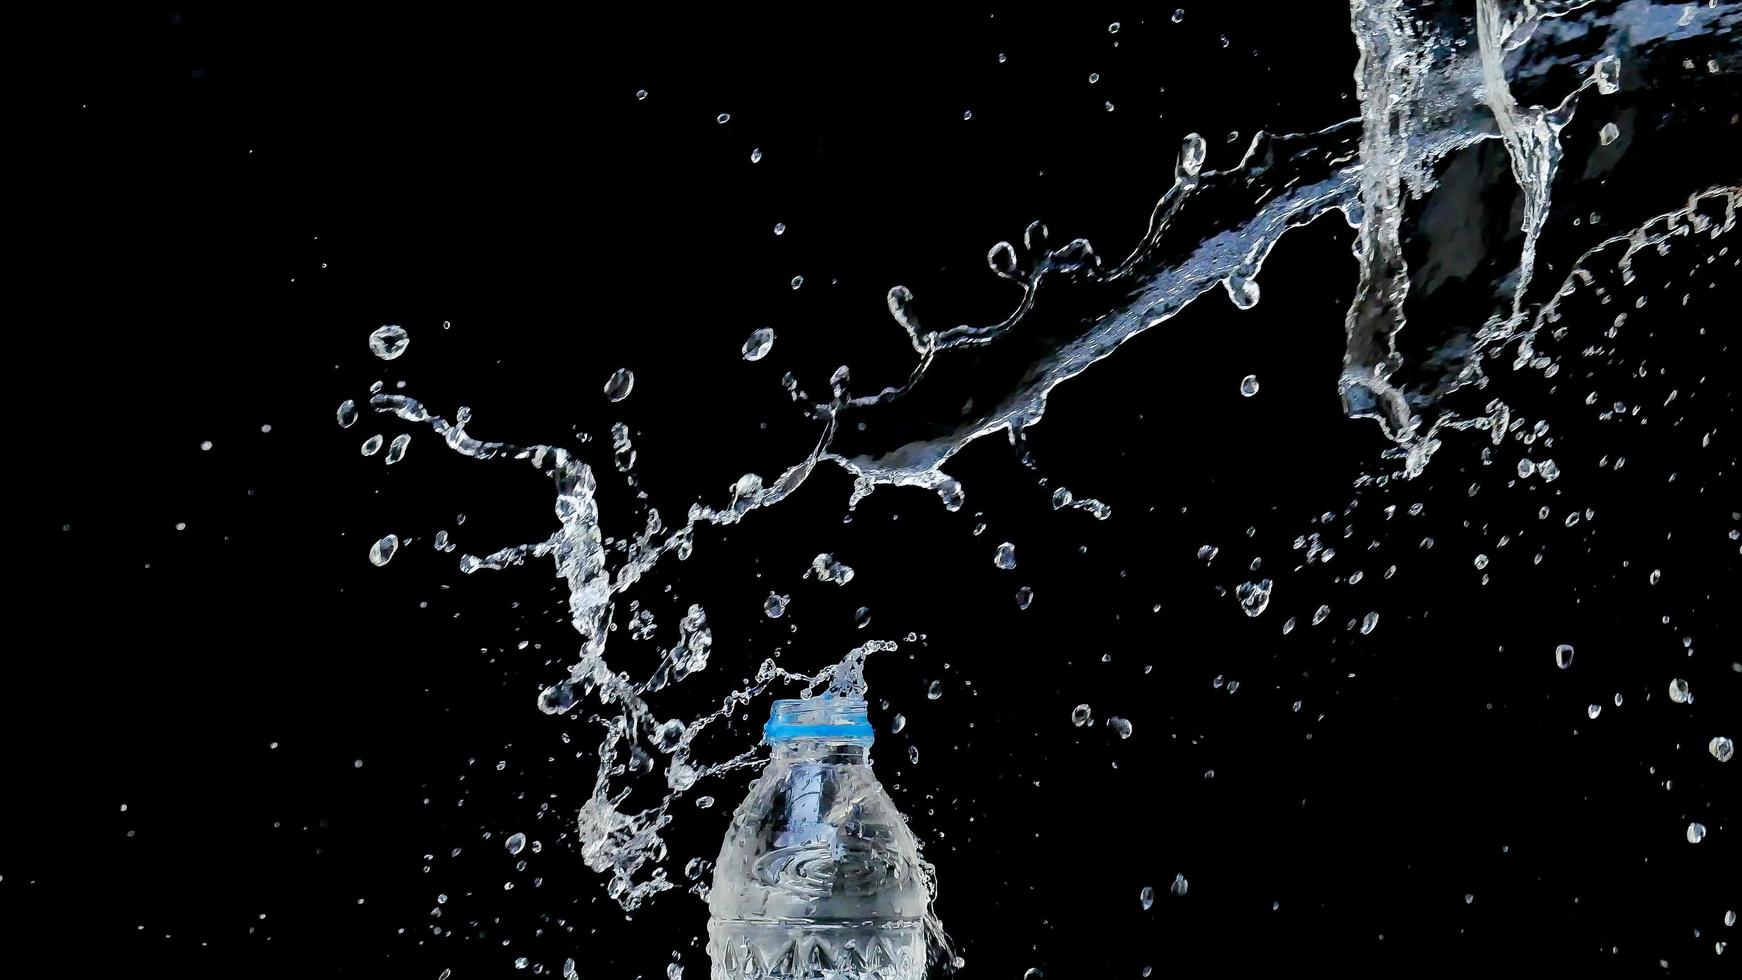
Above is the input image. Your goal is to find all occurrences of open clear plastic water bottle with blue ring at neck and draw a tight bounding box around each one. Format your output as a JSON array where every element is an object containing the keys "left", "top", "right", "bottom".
[{"left": 707, "top": 695, "right": 927, "bottom": 980}]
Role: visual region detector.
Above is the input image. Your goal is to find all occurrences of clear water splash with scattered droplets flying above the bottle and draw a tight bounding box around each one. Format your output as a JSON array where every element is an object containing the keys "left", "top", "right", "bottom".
[{"left": 338, "top": 0, "right": 1742, "bottom": 950}]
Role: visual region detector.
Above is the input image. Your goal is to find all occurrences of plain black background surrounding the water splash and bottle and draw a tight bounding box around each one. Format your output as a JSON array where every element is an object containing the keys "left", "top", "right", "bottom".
[{"left": 13, "top": 3, "right": 1742, "bottom": 980}]
